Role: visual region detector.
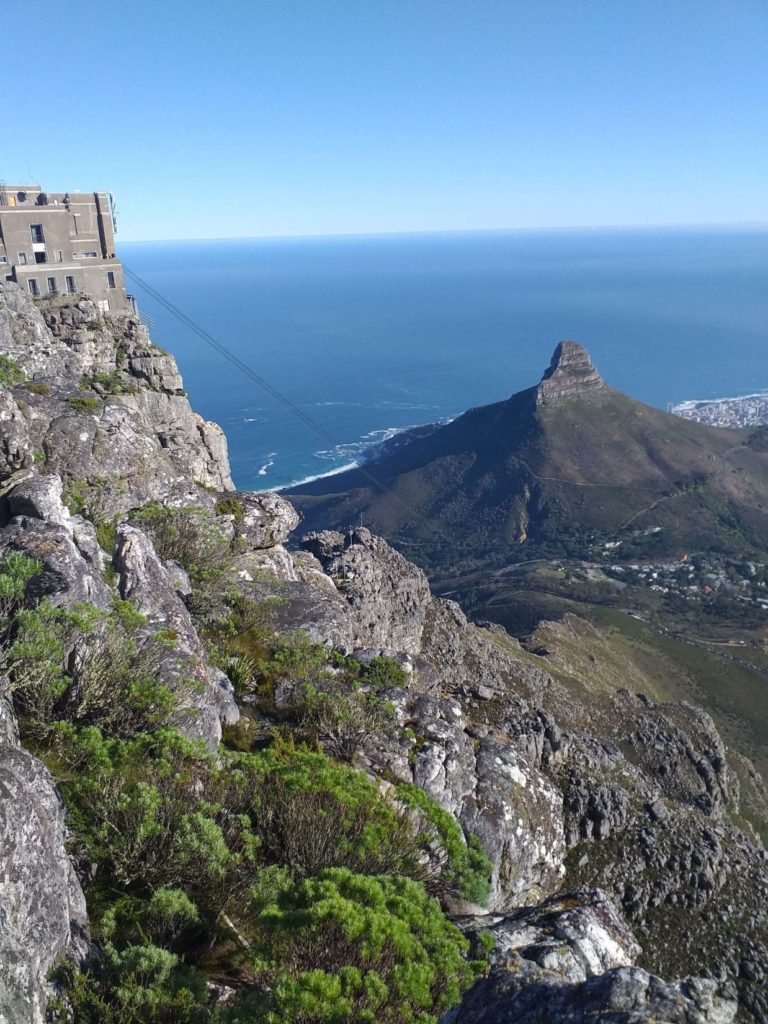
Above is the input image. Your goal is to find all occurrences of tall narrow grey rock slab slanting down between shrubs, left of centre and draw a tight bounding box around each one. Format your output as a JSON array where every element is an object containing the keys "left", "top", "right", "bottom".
[{"left": 115, "top": 524, "right": 240, "bottom": 749}]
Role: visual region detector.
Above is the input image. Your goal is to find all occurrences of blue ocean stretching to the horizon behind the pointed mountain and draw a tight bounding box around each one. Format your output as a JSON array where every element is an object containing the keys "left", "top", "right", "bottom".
[{"left": 120, "top": 230, "right": 768, "bottom": 489}]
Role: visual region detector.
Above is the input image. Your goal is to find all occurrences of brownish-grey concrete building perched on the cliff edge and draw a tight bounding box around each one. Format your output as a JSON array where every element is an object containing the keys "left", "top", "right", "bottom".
[{"left": 0, "top": 184, "right": 132, "bottom": 310}]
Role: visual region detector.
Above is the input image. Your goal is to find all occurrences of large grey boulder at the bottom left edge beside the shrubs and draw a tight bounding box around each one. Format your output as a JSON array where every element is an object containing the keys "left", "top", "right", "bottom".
[{"left": 0, "top": 745, "right": 88, "bottom": 1024}]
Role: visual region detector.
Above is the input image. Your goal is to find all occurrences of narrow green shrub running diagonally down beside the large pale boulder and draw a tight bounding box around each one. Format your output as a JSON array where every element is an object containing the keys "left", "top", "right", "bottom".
[{"left": 395, "top": 782, "right": 493, "bottom": 905}]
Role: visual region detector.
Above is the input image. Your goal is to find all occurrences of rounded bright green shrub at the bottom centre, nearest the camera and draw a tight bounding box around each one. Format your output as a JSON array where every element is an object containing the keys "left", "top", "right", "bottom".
[{"left": 228, "top": 868, "right": 475, "bottom": 1024}]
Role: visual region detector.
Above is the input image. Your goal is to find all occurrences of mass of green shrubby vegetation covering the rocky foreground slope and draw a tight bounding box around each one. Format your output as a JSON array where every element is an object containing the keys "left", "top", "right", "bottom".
[{"left": 0, "top": 540, "right": 490, "bottom": 1024}]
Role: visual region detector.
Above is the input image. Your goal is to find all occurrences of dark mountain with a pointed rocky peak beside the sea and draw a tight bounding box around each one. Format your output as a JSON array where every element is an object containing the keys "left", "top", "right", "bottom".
[{"left": 290, "top": 341, "right": 768, "bottom": 566}]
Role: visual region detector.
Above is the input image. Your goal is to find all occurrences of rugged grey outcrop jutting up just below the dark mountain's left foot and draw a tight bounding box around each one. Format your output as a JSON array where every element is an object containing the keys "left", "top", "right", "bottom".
[{"left": 302, "top": 528, "right": 432, "bottom": 654}]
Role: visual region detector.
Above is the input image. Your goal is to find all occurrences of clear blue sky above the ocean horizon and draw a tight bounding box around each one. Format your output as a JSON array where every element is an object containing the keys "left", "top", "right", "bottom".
[{"left": 6, "top": 0, "right": 768, "bottom": 240}]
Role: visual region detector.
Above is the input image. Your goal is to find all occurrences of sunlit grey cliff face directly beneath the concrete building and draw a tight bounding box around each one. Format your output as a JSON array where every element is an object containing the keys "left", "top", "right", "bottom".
[{"left": 0, "top": 283, "right": 233, "bottom": 516}]
